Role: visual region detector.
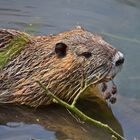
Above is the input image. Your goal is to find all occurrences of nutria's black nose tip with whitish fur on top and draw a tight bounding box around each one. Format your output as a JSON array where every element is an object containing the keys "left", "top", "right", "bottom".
[{"left": 115, "top": 52, "right": 124, "bottom": 66}]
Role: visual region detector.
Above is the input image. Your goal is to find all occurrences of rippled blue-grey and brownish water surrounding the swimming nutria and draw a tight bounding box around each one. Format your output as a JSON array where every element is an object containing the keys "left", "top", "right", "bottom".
[{"left": 0, "top": 0, "right": 140, "bottom": 140}]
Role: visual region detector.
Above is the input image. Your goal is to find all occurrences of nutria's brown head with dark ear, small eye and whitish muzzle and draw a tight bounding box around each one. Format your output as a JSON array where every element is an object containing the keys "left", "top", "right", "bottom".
[{"left": 50, "top": 27, "right": 124, "bottom": 84}]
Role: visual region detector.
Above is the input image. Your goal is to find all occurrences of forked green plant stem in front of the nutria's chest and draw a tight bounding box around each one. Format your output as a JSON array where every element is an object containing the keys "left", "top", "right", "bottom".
[{"left": 37, "top": 81, "right": 125, "bottom": 140}]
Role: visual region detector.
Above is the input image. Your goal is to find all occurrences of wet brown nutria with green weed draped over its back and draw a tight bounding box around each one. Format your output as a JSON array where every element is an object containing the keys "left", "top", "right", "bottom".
[{"left": 0, "top": 27, "right": 124, "bottom": 107}]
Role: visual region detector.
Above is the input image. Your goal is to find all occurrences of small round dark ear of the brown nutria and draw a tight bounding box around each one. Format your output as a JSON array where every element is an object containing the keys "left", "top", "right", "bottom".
[{"left": 55, "top": 42, "right": 67, "bottom": 57}]
